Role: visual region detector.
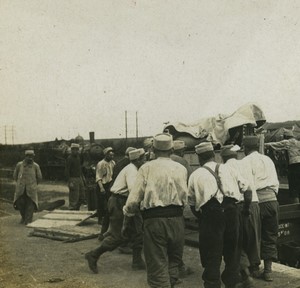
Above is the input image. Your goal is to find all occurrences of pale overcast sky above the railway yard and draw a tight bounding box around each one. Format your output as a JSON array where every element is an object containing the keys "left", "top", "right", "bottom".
[{"left": 0, "top": 0, "right": 300, "bottom": 144}]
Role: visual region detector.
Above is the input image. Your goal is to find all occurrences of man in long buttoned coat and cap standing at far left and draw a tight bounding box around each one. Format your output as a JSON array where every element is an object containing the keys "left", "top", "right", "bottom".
[{"left": 13, "top": 150, "right": 42, "bottom": 225}]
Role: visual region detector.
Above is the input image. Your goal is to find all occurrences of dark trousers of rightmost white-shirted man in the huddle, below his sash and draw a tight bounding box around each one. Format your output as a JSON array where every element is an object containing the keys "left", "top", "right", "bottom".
[{"left": 259, "top": 201, "right": 279, "bottom": 261}]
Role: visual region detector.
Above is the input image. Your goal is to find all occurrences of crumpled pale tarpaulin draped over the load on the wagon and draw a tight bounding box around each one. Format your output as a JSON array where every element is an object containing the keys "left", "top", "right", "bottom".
[{"left": 165, "top": 103, "right": 266, "bottom": 145}]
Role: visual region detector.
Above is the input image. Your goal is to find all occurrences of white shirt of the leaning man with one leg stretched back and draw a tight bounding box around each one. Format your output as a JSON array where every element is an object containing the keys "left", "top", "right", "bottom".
[{"left": 110, "top": 163, "right": 138, "bottom": 197}]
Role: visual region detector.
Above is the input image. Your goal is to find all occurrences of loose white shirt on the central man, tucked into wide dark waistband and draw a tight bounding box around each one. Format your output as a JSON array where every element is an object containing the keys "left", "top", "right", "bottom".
[{"left": 123, "top": 157, "right": 187, "bottom": 216}]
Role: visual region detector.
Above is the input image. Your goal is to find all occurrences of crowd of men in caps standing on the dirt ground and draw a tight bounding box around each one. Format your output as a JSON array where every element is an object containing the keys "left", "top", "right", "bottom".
[{"left": 14, "top": 133, "right": 298, "bottom": 288}]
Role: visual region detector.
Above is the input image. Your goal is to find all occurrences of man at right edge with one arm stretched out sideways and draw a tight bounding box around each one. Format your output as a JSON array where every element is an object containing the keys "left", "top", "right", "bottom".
[{"left": 265, "top": 130, "right": 300, "bottom": 203}]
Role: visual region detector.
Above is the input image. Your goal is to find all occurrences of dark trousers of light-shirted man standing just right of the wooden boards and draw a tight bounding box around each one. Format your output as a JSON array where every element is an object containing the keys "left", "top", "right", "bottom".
[{"left": 96, "top": 183, "right": 111, "bottom": 234}]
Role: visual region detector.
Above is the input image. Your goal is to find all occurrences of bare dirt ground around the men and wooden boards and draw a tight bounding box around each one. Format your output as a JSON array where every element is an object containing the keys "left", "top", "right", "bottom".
[{"left": 0, "top": 181, "right": 300, "bottom": 288}]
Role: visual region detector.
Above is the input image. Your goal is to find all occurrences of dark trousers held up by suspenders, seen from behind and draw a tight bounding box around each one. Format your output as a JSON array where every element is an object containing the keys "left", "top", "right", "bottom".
[{"left": 199, "top": 197, "right": 241, "bottom": 288}]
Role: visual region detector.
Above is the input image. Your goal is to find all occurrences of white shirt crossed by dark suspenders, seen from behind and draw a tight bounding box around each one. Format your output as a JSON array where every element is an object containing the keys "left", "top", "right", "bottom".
[{"left": 188, "top": 161, "right": 249, "bottom": 211}]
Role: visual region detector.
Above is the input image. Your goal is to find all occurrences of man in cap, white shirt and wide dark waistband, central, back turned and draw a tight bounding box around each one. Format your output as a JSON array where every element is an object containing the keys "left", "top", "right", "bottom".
[{"left": 123, "top": 133, "right": 187, "bottom": 288}]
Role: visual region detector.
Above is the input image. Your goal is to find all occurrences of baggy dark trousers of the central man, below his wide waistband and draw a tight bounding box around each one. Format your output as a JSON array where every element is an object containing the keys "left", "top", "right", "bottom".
[{"left": 144, "top": 216, "right": 184, "bottom": 288}]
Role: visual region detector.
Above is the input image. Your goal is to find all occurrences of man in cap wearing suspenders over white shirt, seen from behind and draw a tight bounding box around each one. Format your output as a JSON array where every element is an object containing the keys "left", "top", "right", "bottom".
[{"left": 188, "top": 142, "right": 251, "bottom": 288}]
